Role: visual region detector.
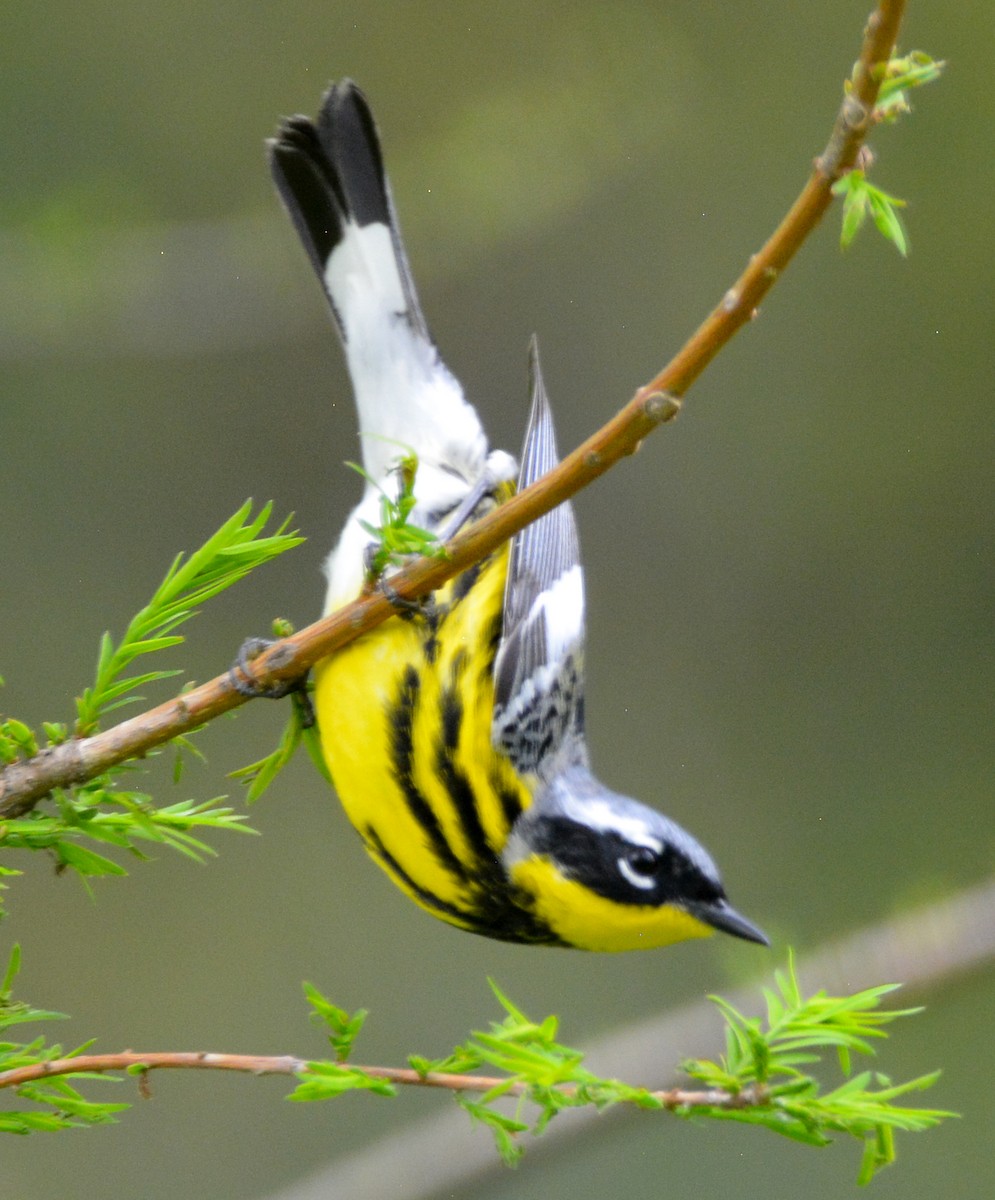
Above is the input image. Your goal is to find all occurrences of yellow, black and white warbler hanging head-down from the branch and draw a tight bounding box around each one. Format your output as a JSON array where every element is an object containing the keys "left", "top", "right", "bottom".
[{"left": 268, "top": 79, "right": 769, "bottom": 952}]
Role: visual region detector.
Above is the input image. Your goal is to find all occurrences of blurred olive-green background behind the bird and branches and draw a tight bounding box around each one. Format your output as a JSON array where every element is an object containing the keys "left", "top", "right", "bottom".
[{"left": 0, "top": 0, "right": 995, "bottom": 1200}]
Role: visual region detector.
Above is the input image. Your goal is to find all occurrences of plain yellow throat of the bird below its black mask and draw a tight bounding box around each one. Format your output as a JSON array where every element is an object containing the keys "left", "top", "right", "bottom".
[{"left": 511, "top": 856, "right": 714, "bottom": 950}]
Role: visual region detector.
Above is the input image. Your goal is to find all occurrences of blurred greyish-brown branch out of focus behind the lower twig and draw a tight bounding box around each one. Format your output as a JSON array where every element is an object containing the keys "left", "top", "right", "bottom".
[{"left": 279, "top": 876, "right": 995, "bottom": 1200}]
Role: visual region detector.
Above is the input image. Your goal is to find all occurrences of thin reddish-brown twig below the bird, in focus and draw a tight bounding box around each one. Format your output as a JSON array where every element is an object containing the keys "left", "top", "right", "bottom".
[{"left": 0, "top": 1050, "right": 769, "bottom": 1110}]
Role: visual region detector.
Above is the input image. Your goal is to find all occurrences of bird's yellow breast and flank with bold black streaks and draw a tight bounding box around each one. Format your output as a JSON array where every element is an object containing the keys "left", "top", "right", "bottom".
[{"left": 314, "top": 547, "right": 532, "bottom": 928}]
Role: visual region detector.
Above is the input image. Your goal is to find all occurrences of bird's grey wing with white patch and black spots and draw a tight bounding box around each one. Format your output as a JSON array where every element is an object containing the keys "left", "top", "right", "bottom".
[{"left": 492, "top": 338, "right": 587, "bottom": 778}]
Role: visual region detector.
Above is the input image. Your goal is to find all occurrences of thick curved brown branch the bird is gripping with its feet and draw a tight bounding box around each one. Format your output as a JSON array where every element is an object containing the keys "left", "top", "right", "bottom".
[{"left": 0, "top": 0, "right": 905, "bottom": 820}]
